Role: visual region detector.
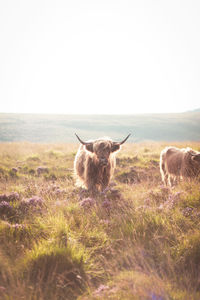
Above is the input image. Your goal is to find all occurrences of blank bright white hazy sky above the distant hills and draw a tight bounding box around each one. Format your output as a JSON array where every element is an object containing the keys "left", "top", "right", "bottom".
[{"left": 0, "top": 0, "right": 200, "bottom": 114}]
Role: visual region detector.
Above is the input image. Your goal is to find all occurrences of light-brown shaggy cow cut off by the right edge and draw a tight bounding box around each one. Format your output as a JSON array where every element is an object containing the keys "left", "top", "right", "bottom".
[{"left": 160, "top": 147, "right": 200, "bottom": 186}]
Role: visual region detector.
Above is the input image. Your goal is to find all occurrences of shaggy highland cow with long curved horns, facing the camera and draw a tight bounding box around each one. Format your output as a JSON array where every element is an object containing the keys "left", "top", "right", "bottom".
[{"left": 74, "top": 134, "right": 130, "bottom": 192}]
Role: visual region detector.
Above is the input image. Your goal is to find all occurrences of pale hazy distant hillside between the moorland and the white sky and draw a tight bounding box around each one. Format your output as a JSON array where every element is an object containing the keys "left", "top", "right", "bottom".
[{"left": 0, "top": 112, "right": 200, "bottom": 143}]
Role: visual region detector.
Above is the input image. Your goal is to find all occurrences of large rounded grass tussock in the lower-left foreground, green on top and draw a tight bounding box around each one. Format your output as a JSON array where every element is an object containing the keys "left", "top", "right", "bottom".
[{"left": 23, "top": 240, "right": 87, "bottom": 299}]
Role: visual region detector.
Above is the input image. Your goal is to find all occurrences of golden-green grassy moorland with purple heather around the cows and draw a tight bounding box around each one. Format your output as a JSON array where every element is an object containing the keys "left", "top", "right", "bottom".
[{"left": 0, "top": 143, "right": 200, "bottom": 300}]
